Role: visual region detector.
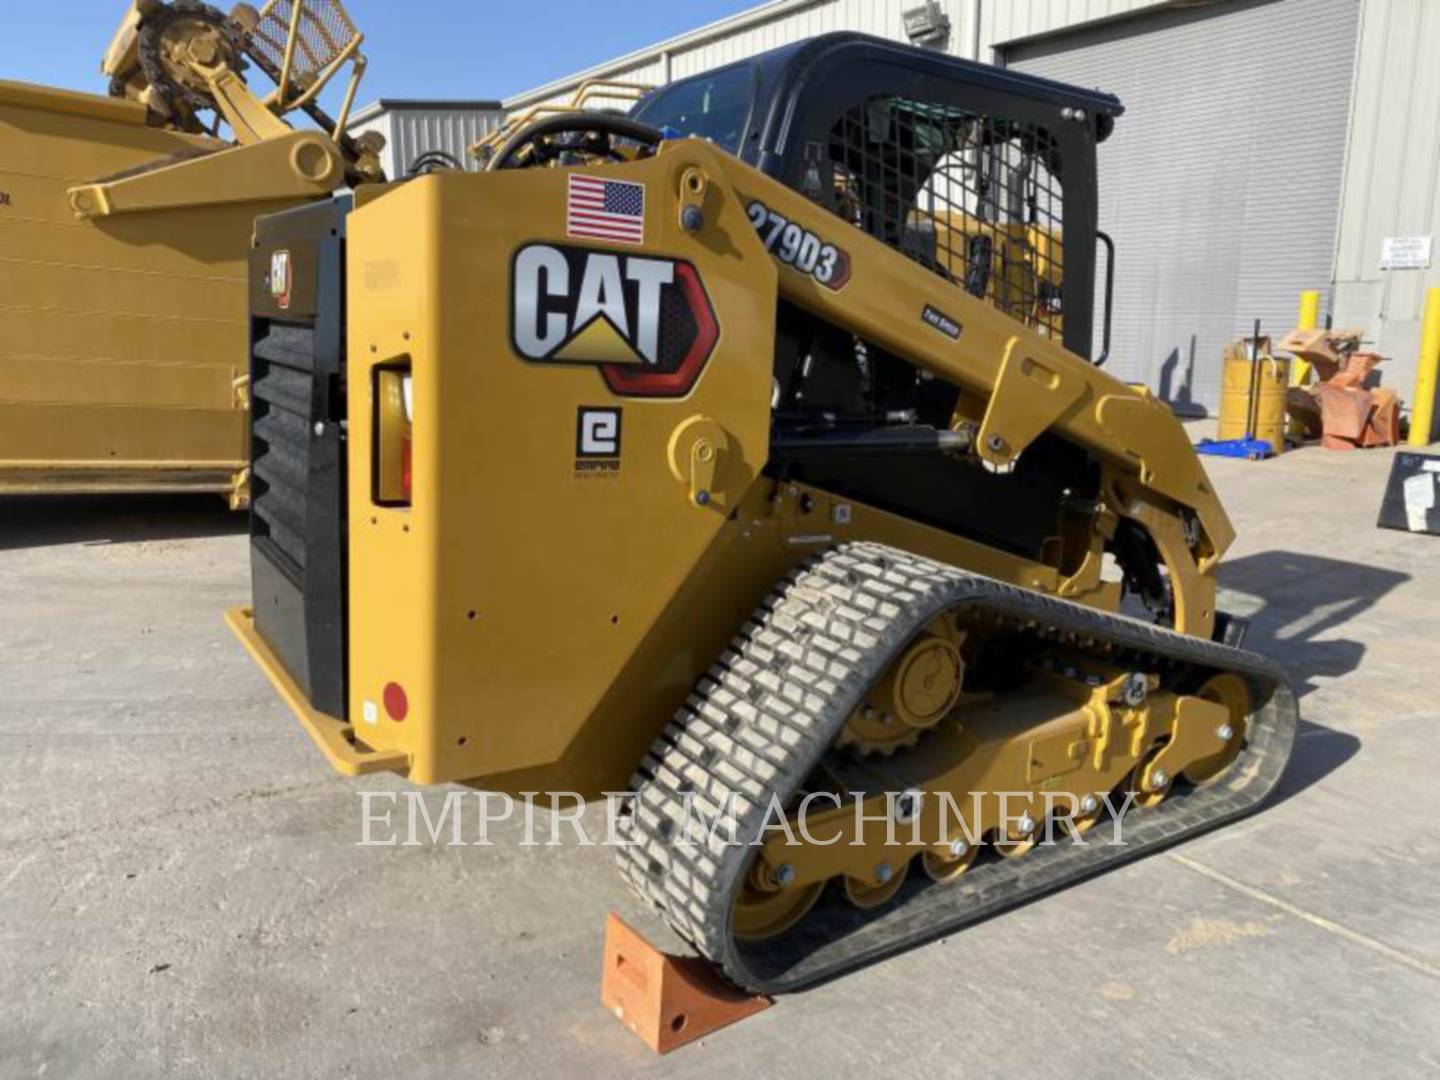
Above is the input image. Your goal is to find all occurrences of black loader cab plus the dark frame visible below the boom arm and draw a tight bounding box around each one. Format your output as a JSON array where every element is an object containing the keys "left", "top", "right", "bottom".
[{"left": 632, "top": 33, "right": 1122, "bottom": 593}]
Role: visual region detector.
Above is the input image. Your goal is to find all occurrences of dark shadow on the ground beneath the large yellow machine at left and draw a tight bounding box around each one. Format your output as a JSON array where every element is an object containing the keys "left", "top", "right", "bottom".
[{"left": 0, "top": 494, "right": 248, "bottom": 552}]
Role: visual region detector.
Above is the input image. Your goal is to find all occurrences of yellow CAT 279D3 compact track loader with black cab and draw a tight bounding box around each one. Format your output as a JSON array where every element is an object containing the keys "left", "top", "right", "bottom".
[{"left": 229, "top": 35, "right": 1296, "bottom": 992}]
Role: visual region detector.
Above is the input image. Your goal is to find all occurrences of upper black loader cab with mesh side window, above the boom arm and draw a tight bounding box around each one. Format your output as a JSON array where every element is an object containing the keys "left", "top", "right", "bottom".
[{"left": 632, "top": 33, "right": 1123, "bottom": 359}]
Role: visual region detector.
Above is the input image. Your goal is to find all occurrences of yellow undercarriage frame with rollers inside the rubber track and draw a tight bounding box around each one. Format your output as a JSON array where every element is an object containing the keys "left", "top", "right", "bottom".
[{"left": 752, "top": 668, "right": 1238, "bottom": 888}]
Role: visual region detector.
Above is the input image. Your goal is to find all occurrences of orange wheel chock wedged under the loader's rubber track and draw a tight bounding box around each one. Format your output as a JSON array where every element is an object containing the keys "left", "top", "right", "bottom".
[{"left": 600, "top": 912, "right": 775, "bottom": 1054}]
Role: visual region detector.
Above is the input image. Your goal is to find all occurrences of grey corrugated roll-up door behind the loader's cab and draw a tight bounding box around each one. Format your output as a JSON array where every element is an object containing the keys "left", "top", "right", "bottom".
[{"left": 1005, "top": 0, "right": 1359, "bottom": 412}]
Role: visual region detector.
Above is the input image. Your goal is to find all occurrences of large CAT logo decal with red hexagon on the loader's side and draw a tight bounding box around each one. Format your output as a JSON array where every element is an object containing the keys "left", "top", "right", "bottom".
[{"left": 510, "top": 243, "right": 720, "bottom": 397}]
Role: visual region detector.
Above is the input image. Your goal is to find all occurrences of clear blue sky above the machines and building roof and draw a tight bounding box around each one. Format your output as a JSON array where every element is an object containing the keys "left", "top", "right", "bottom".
[{"left": 0, "top": 0, "right": 757, "bottom": 104}]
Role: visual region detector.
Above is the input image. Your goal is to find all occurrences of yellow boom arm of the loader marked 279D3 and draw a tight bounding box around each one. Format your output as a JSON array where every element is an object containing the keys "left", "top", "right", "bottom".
[{"left": 662, "top": 140, "right": 1234, "bottom": 636}]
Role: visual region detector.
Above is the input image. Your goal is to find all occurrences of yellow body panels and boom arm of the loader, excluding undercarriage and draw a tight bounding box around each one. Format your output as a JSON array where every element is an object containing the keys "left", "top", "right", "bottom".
[{"left": 236, "top": 140, "right": 1233, "bottom": 793}]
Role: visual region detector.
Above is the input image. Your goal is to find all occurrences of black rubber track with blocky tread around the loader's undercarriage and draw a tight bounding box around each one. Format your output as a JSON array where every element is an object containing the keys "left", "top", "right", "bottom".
[{"left": 619, "top": 543, "right": 1297, "bottom": 994}]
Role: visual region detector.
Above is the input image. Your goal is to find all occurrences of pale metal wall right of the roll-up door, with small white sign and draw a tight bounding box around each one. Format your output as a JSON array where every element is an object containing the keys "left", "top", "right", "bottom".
[{"left": 1335, "top": 0, "right": 1440, "bottom": 400}]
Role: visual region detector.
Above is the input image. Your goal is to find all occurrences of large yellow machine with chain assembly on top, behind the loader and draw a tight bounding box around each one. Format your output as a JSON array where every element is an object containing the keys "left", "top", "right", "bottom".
[{"left": 0, "top": 0, "right": 383, "bottom": 505}]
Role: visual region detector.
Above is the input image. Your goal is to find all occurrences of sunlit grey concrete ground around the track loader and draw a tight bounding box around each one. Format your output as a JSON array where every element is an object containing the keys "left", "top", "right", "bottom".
[{"left": 0, "top": 449, "right": 1440, "bottom": 1079}]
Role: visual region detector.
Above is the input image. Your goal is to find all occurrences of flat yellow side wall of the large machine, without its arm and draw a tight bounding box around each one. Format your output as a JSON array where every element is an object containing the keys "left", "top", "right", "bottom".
[{"left": 0, "top": 82, "right": 249, "bottom": 498}]
